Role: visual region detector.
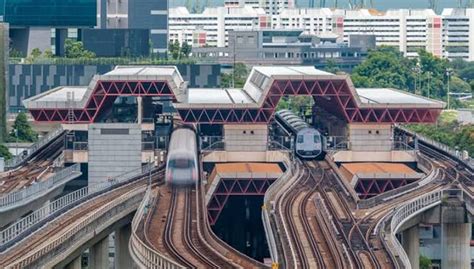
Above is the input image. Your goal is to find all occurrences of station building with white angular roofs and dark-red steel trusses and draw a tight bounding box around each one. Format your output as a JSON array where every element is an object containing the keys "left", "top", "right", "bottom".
[{"left": 24, "top": 66, "right": 444, "bottom": 186}]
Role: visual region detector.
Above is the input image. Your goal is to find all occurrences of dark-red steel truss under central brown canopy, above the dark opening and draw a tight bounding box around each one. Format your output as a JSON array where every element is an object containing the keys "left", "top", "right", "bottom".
[{"left": 207, "top": 178, "right": 276, "bottom": 225}]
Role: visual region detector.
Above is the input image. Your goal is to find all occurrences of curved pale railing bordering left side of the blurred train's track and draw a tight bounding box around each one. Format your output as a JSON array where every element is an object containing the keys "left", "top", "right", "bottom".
[{"left": 128, "top": 189, "right": 184, "bottom": 269}]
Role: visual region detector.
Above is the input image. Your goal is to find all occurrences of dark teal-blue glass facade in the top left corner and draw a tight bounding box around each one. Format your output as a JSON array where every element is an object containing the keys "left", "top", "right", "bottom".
[{"left": 0, "top": 0, "right": 97, "bottom": 27}]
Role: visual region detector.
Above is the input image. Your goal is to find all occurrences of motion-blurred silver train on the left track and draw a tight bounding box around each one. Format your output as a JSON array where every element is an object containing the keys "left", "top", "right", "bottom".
[{"left": 165, "top": 128, "right": 199, "bottom": 185}]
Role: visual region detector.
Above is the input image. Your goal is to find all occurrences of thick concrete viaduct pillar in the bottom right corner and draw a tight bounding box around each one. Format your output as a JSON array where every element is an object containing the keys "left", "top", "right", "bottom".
[{"left": 441, "top": 223, "right": 471, "bottom": 269}]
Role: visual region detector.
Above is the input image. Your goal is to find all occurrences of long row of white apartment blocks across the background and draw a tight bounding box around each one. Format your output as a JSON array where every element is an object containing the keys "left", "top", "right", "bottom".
[{"left": 169, "top": 5, "right": 474, "bottom": 61}]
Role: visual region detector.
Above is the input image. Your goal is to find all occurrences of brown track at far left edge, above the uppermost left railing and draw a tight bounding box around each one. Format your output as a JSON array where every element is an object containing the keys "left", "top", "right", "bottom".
[{"left": 0, "top": 135, "right": 64, "bottom": 195}]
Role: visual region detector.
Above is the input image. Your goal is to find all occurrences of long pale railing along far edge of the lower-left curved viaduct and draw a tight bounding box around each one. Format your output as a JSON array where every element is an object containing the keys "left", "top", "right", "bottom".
[{"left": 0, "top": 161, "right": 153, "bottom": 251}]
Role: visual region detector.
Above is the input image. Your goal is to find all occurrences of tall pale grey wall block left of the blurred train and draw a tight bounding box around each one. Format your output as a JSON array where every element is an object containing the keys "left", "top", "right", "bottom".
[{"left": 88, "top": 123, "right": 142, "bottom": 186}]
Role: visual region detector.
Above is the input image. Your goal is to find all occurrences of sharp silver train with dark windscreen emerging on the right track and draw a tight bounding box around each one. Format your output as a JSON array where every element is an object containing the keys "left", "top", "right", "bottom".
[{"left": 275, "top": 109, "right": 323, "bottom": 159}]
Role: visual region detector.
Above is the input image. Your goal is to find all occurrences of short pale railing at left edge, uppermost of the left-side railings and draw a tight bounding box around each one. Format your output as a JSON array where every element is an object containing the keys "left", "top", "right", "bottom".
[{"left": 0, "top": 164, "right": 82, "bottom": 212}]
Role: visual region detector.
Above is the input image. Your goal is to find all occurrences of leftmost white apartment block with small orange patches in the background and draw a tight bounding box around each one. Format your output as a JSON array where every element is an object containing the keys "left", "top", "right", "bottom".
[{"left": 169, "top": 6, "right": 271, "bottom": 47}]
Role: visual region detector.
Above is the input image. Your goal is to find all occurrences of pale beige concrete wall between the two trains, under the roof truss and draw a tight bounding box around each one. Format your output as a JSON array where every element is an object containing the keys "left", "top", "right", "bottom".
[{"left": 224, "top": 125, "right": 268, "bottom": 151}]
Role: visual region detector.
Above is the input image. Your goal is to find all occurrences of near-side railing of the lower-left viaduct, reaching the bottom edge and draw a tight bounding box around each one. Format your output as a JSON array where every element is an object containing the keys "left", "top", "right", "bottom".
[{"left": 8, "top": 186, "right": 145, "bottom": 268}]
